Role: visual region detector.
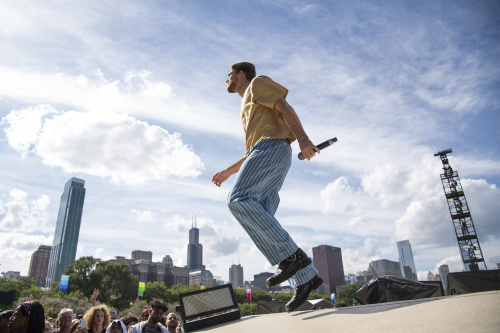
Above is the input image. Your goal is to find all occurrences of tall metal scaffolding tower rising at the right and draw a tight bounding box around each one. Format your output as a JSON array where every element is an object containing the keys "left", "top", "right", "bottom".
[{"left": 434, "top": 149, "right": 487, "bottom": 271}]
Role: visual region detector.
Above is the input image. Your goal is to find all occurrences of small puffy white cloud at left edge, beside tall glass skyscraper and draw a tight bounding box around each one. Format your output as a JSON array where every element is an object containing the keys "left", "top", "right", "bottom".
[{"left": 0, "top": 189, "right": 50, "bottom": 233}]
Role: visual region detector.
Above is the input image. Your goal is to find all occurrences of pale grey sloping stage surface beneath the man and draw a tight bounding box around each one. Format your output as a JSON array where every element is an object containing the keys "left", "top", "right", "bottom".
[{"left": 192, "top": 291, "right": 500, "bottom": 333}]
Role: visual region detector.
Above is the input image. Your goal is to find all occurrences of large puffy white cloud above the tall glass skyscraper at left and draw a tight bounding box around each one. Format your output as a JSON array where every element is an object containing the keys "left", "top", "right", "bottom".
[{"left": 2, "top": 106, "right": 204, "bottom": 184}]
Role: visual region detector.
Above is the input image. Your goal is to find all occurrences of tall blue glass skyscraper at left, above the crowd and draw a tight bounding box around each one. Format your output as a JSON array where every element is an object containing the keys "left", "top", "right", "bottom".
[{"left": 45, "top": 177, "right": 85, "bottom": 287}]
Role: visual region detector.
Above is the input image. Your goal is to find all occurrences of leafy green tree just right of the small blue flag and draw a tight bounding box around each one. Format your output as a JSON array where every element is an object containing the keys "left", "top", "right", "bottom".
[{"left": 64, "top": 256, "right": 102, "bottom": 298}]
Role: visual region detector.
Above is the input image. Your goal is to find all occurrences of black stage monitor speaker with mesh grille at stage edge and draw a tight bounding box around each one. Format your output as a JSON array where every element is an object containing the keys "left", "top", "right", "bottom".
[{"left": 179, "top": 283, "right": 241, "bottom": 332}]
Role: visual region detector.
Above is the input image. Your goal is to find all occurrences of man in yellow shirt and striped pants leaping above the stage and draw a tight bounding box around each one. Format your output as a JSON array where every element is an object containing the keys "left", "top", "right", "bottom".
[{"left": 212, "top": 62, "right": 323, "bottom": 312}]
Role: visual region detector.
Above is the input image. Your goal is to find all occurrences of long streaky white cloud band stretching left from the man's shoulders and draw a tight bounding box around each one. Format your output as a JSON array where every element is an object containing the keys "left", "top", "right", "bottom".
[{"left": 0, "top": 66, "right": 241, "bottom": 136}]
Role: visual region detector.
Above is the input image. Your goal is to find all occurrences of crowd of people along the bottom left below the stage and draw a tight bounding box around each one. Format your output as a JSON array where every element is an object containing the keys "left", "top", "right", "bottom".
[{"left": 0, "top": 290, "right": 183, "bottom": 333}]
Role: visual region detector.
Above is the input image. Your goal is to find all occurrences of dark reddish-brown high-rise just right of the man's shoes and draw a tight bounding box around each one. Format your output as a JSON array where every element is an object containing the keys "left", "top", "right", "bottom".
[{"left": 313, "top": 245, "right": 345, "bottom": 295}]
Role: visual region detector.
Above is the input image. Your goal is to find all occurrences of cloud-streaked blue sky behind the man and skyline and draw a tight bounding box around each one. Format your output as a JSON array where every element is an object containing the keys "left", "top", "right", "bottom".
[{"left": 0, "top": 1, "right": 500, "bottom": 280}]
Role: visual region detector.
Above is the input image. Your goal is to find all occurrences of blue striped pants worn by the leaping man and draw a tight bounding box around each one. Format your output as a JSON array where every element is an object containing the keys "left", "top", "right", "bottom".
[{"left": 228, "top": 139, "right": 318, "bottom": 288}]
